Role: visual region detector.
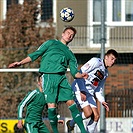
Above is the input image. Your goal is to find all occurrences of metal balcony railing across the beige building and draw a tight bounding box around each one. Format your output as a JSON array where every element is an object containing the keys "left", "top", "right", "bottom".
[{"left": 69, "top": 25, "right": 133, "bottom": 53}]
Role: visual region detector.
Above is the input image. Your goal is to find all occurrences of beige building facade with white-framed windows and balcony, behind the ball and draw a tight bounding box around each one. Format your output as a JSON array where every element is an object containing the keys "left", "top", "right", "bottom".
[{"left": 56, "top": 0, "right": 133, "bottom": 53}]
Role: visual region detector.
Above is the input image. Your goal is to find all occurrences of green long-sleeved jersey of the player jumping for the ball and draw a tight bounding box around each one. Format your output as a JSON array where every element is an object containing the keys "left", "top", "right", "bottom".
[{"left": 28, "top": 40, "right": 78, "bottom": 77}]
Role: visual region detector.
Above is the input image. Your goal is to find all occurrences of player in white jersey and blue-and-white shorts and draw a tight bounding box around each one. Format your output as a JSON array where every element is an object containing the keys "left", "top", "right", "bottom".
[{"left": 67, "top": 49, "right": 118, "bottom": 133}]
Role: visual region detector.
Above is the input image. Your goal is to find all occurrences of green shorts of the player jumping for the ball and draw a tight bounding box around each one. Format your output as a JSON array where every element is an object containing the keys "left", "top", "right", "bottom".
[{"left": 42, "top": 74, "right": 74, "bottom": 103}]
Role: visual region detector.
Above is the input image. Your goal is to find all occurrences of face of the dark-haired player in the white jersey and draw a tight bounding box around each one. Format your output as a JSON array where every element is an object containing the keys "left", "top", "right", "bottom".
[{"left": 105, "top": 54, "right": 116, "bottom": 67}]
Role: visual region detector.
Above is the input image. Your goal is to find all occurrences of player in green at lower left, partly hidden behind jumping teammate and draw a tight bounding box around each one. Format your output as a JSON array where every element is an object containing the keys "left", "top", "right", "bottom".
[{"left": 17, "top": 74, "right": 64, "bottom": 133}]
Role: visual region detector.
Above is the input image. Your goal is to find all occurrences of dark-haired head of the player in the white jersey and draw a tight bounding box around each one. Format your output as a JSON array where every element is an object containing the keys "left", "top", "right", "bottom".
[{"left": 104, "top": 49, "right": 118, "bottom": 67}]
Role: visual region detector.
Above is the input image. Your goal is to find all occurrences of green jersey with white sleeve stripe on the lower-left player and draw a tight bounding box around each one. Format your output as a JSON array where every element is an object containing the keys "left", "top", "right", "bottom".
[{"left": 18, "top": 88, "right": 46, "bottom": 123}]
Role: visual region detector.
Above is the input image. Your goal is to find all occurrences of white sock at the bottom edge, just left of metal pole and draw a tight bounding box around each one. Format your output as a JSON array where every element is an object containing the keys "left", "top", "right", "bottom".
[{"left": 87, "top": 119, "right": 97, "bottom": 133}]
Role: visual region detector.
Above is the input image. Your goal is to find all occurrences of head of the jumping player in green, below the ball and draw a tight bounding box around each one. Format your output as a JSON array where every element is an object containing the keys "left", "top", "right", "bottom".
[{"left": 61, "top": 26, "right": 77, "bottom": 44}]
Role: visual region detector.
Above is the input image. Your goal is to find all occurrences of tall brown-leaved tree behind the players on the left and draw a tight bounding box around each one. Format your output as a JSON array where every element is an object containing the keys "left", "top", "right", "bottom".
[{"left": 0, "top": 0, "right": 55, "bottom": 117}]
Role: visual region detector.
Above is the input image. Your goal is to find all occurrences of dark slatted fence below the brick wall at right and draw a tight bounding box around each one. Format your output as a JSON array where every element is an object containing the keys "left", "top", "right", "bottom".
[{"left": 106, "top": 88, "right": 133, "bottom": 117}]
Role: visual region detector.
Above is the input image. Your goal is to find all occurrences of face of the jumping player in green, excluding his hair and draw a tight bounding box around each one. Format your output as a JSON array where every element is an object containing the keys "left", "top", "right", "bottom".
[{"left": 62, "top": 29, "right": 74, "bottom": 44}]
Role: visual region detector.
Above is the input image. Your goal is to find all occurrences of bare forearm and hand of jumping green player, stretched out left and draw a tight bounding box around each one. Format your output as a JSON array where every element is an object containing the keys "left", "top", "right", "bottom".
[{"left": 8, "top": 56, "right": 31, "bottom": 68}]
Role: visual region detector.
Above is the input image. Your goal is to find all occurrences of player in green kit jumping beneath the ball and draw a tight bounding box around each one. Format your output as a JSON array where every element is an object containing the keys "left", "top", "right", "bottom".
[{"left": 9, "top": 27, "right": 88, "bottom": 133}]
